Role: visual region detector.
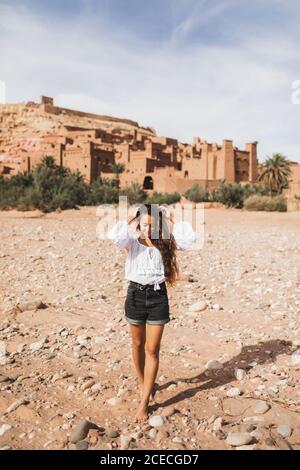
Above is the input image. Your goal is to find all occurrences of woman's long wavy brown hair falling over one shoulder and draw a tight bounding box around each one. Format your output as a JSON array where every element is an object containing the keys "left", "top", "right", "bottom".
[{"left": 129, "top": 204, "right": 179, "bottom": 286}]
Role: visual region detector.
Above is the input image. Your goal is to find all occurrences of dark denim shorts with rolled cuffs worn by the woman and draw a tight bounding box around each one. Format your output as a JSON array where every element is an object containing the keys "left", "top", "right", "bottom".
[{"left": 125, "top": 281, "right": 170, "bottom": 325}]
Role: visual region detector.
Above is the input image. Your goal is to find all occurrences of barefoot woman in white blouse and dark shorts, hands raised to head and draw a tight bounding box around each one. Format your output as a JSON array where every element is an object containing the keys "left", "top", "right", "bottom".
[{"left": 107, "top": 204, "right": 196, "bottom": 423}]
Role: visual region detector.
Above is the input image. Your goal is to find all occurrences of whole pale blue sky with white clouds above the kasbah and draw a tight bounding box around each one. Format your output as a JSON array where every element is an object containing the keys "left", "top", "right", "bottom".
[{"left": 0, "top": 0, "right": 300, "bottom": 163}]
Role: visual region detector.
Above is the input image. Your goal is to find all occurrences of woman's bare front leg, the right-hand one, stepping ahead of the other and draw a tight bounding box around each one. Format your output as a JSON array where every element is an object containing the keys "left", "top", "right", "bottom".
[{"left": 134, "top": 325, "right": 165, "bottom": 423}]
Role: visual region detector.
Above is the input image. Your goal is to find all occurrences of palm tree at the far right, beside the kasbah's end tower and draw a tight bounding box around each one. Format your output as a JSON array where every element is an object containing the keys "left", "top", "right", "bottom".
[{"left": 258, "top": 153, "right": 292, "bottom": 196}]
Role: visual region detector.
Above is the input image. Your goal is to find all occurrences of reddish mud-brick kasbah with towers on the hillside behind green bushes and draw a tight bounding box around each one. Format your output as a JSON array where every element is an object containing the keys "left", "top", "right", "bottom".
[{"left": 0, "top": 96, "right": 300, "bottom": 208}]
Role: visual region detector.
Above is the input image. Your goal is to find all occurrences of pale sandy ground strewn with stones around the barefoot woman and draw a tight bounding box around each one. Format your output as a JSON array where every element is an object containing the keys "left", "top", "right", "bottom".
[{"left": 0, "top": 207, "right": 300, "bottom": 450}]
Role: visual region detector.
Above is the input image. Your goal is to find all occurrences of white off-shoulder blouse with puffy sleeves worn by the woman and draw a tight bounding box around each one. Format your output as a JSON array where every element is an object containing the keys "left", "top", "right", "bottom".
[{"left": 107, "top": 220, "right": 197, "bottom": 290}]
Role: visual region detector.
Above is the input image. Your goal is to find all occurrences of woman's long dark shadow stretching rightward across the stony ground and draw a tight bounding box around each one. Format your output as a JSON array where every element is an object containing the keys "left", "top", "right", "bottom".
[{"left": 150, "top": 339, "right": 297, "bottom": 411}]
